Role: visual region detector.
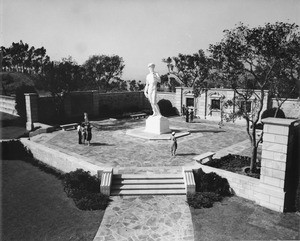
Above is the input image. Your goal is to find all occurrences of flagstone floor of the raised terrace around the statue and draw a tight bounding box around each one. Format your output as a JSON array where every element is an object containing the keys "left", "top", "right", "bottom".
[{"left": 31, "top": 117, "right": 250, "bottom": 173}]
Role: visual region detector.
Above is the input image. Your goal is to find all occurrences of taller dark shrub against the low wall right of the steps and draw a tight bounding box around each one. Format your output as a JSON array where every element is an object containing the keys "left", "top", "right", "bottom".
[{"left": 194, "top": 168, "right": 231, "bottom": 197}]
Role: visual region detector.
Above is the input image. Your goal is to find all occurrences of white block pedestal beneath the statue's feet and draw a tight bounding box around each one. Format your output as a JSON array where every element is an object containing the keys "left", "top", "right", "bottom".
[{"left": 145, "top": 116, "right": 171, "bottom": 135}]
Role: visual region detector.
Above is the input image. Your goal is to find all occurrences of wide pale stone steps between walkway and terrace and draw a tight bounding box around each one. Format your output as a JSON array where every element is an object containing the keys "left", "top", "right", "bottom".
[{"left": 110, "top": 174, "right": 186, "bottom": 196}]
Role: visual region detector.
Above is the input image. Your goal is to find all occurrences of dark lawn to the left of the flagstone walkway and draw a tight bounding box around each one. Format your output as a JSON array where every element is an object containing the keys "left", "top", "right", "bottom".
[{"left": 1, "top": 160, "right": 104, "bottom": 241}]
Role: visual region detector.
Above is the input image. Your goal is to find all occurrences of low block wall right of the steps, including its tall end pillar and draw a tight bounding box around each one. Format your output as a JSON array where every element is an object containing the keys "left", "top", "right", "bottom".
[{"left": 196, "top": 118, "right": 300, "bottom": 212}]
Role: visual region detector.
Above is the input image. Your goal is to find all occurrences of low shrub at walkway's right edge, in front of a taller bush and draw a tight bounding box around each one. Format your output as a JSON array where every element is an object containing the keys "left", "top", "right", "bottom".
[{"left": 187, "top": 192, "right": 222, "bottom": 208}]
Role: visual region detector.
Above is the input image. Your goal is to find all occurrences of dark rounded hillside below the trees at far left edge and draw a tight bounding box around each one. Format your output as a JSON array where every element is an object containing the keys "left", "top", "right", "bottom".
[{"left": 0, "top": 72, "right": 34, "bottom": 95}]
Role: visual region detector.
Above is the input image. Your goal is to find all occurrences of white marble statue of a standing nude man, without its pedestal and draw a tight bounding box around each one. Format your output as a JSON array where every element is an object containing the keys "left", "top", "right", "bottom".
[{"left": 144, "top": 63, "right": 161, "bottom": 116}]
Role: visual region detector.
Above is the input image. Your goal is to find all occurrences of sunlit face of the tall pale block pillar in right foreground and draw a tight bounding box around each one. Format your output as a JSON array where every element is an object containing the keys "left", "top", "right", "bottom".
[{"left": 254, "top": 118, "right": 296, "bottom": 212}]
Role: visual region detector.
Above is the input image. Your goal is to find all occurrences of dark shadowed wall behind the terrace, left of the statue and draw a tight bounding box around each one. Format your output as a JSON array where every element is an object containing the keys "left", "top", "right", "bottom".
[{"left": 37, "top": 91, "right": 150, "bottom": 122}]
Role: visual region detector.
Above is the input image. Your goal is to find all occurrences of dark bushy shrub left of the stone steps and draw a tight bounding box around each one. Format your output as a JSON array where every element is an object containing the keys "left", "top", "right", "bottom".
[{"left": 63, "top": 169, "right": 110, "bottom": 210}]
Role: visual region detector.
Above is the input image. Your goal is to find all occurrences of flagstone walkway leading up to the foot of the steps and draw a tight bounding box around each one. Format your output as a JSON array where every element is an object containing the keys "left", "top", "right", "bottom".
[{"left": 94, "top": 196, "right": 194, "bottom": 241}]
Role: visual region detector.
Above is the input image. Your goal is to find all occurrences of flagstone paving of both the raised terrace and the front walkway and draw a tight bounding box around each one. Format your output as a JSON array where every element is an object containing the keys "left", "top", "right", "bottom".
[{"left": 31, "top": 117, "right": 250, "bottom": 241}]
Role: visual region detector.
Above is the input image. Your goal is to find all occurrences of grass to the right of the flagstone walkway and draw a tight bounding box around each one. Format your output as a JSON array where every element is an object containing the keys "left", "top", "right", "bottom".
[{"left": 190, "top": 196, "right": 300, "bottom": 241}]
